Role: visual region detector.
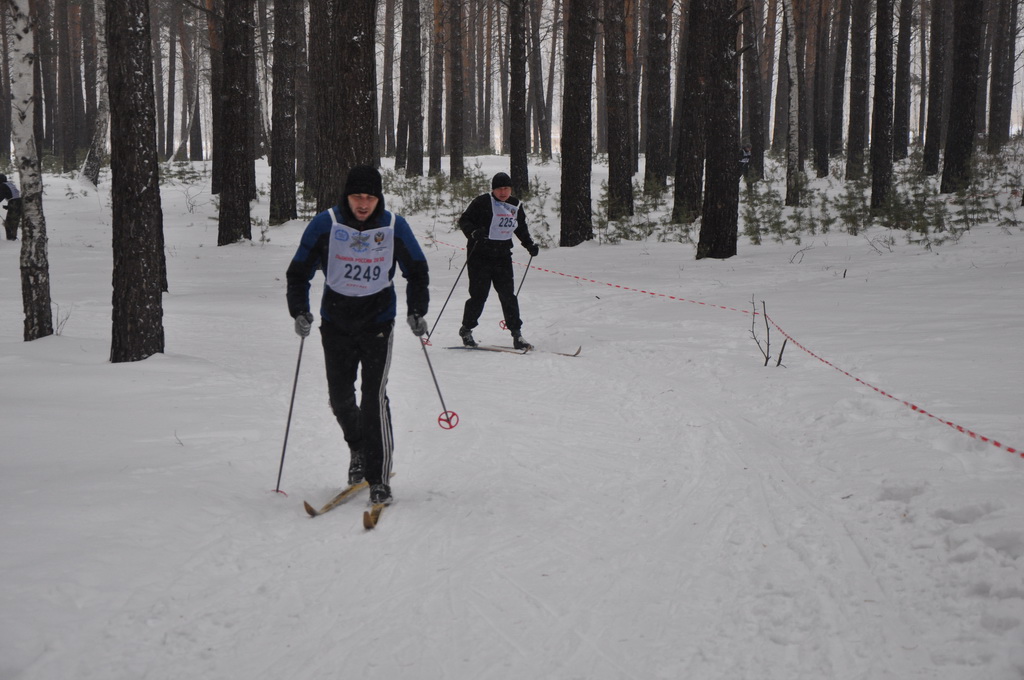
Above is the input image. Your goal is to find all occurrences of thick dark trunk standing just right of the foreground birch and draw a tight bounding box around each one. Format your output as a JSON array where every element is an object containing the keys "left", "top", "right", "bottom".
[{"left": 106, "top": 0, "right": 167, "bottom": 364}]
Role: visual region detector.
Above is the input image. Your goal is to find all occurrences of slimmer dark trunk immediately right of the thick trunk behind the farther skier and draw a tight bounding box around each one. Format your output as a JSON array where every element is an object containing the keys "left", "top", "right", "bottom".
[{"left": 604, "top": 0, "right": 633, "bottom": 221}]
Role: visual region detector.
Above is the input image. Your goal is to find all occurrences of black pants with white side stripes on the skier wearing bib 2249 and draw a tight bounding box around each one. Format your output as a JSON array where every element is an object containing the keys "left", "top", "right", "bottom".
[{"left": 321, "top": 322, "right": 394, "bottom": 484}]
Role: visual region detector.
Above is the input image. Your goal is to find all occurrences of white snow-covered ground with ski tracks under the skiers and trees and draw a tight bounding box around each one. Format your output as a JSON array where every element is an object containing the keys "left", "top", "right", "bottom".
[{"left": 0, "top": 158, "right": 1024, "bottom": 680}]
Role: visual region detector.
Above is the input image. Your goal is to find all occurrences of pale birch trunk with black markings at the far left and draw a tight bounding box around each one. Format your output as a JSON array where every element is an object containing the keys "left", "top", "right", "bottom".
[{"left": 7, "top": 0, "right": 53, "bottom": 341}]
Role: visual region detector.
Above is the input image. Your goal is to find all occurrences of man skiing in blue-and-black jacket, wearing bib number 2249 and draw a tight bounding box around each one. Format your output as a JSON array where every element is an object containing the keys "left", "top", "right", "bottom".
[{"left": 287, "top": 166, "right": 430, "bottom": 504}]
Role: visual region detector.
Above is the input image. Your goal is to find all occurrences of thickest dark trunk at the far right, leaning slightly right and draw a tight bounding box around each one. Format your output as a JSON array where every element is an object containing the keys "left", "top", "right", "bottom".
[{"left": 939, "top": 0, "right": 983, "bottom": 194}]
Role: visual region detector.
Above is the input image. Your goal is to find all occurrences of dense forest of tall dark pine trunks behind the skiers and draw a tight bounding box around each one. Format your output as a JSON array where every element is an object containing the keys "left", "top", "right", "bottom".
[{"left": 0, "top": 0, "right": 1020, "bottom": 354}]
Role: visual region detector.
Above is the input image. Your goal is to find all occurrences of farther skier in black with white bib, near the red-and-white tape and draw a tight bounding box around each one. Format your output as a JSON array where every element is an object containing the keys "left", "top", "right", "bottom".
[{"left": 459, "top": 172, "right": 541, "bottom": 350}]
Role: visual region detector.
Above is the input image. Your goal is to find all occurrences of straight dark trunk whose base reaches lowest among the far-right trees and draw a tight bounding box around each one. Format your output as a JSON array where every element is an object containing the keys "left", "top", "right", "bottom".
[{"left": 871, "top": 0, "right": 894, "bottom": 211}]
